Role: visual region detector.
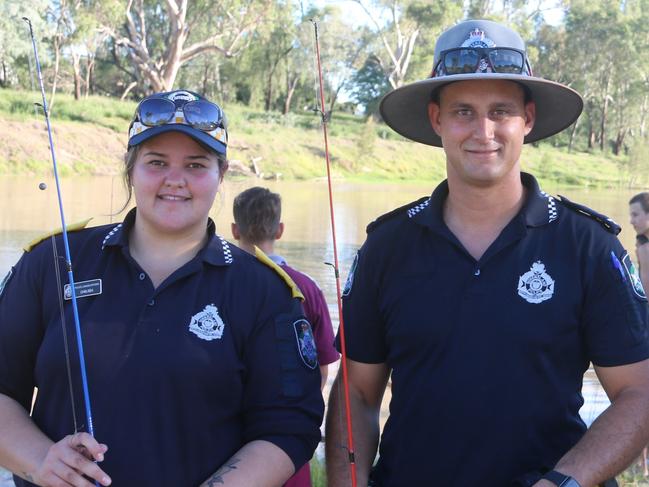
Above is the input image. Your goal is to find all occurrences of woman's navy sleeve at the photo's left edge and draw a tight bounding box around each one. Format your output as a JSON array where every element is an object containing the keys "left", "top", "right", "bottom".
[{"left": 0, "top": 253, "right": 44, "bottom": 410}]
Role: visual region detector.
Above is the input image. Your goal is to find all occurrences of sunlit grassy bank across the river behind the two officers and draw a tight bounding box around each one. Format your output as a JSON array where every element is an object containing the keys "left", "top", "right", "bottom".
[{"left": 0, "top": 86, "right": 636, "bottom": 187}]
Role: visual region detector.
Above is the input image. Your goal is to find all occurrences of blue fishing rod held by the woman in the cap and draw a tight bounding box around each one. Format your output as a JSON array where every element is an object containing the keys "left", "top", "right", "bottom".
[{"left": 23, "top": 17, "right": 99, "bottom": 458}]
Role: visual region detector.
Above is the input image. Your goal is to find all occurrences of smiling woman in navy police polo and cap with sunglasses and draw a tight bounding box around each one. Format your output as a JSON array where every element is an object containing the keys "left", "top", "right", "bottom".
[{"left": 0, "top": 91, "right": 323, "bottom": 487}]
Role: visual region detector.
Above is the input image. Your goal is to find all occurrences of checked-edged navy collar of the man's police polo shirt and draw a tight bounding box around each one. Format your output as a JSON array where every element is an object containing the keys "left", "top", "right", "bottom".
[{"left": 408, "top": 172, "right": 558, "bottom": 233}]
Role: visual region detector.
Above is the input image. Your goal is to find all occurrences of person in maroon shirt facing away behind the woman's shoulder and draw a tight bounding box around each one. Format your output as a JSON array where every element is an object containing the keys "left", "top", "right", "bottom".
[{"left": 232, "top": 186, "right": 339, "bottom": 487}]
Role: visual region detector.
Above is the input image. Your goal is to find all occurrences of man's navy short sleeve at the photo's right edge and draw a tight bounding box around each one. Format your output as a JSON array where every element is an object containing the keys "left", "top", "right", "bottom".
[{"left": 583, "top": 238, "right": 649, "bottom": 367}]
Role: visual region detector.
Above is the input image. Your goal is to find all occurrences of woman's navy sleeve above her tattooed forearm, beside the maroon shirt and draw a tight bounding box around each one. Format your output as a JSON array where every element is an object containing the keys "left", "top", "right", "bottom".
[{"left": 243, "top": 299, "right": 324, "bottom": 470}]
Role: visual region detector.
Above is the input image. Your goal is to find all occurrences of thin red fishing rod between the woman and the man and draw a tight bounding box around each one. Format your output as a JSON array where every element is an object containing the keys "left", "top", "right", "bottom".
[{"left": 309, "top": 19, "right": 356, "bottom": 487}]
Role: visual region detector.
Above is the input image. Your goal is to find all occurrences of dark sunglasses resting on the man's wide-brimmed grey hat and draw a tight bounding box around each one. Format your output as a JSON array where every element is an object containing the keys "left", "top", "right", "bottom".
[{"left": 432, "top": 47, "right": 532, "bottom": 78}]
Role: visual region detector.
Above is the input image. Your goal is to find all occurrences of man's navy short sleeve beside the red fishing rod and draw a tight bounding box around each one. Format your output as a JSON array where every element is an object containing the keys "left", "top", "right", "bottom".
[{"left": 336, "top": 246, "right": 387, "bottom": 363}]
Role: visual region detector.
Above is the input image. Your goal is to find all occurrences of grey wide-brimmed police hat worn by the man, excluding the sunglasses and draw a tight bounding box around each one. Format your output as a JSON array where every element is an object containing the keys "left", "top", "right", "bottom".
[{"left": 379, "top": 20, "right": 584, "bottom": 147}]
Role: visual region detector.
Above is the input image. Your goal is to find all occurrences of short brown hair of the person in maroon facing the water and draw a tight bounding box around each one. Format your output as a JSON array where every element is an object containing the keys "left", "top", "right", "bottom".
[{"left": 232, "top": 186, "right": 282, "bottom": 244}]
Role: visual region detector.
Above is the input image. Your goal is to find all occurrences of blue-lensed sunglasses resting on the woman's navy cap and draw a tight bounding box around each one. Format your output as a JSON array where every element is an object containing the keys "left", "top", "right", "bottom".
[{"left": 135, "top": 98, "right": 227, "bottom": 132}]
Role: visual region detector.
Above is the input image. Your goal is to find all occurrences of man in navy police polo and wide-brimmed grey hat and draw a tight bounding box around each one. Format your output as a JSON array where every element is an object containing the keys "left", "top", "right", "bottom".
[{"left": 327, "top": 20, "right": 649, "bottom": 487}]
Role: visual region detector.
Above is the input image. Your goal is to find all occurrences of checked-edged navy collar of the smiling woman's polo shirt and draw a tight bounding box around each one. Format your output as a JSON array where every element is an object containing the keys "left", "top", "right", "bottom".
[{"left": 101, "top": 208, "right": 234, "bottom": 266}]
